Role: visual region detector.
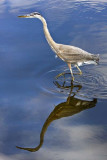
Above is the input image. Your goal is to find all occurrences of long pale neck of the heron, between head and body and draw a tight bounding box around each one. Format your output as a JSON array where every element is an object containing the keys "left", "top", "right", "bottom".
[{"left": 39, "top": 16, "right": 56, "bottom": 50}]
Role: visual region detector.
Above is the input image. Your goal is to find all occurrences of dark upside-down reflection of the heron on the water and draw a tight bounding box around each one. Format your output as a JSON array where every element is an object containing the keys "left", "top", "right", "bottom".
[{"left": 16, "top": 81, "right": 97, "bottom": 152}]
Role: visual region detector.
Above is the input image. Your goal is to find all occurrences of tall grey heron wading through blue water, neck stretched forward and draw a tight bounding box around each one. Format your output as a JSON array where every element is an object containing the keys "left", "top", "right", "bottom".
[{"left": 18, "top": 12, "right": 99, "bottom": 81}]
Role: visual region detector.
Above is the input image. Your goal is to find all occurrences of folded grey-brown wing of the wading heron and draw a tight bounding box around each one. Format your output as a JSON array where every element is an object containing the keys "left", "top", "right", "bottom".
[{"left": 59, "top": 44, "right": 96, "bottom": 64}]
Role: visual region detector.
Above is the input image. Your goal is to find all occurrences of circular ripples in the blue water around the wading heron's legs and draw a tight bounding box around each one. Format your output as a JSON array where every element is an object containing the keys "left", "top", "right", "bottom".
[{"left": 39, "top": 55, "right": 107, "bottom": 99}]
